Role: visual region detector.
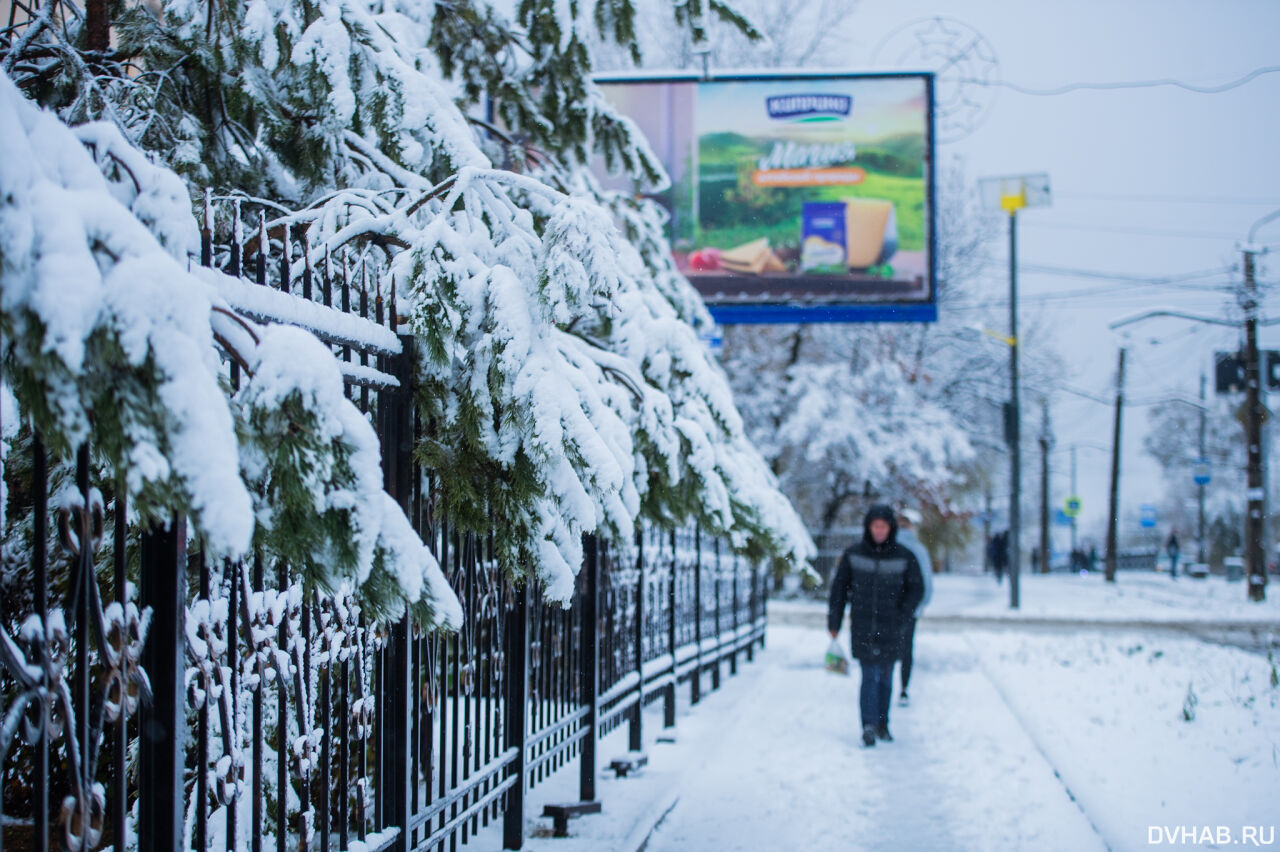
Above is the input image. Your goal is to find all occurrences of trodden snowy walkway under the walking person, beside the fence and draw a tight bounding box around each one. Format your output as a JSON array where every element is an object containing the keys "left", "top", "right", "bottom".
[{"left": 645, "top": 627, "right": 1106, "bottom": 852}]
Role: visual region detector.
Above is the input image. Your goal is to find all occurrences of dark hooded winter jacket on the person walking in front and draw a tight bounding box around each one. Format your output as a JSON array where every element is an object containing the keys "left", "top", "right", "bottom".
[{"left": 827, "top": 505, "right": 924, "bottom": 663}]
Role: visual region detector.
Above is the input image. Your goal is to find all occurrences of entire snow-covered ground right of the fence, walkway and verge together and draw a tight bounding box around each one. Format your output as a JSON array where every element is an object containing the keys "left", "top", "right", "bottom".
[{"left": 476, "top": 576, "right": 1280, "bottom": 852}]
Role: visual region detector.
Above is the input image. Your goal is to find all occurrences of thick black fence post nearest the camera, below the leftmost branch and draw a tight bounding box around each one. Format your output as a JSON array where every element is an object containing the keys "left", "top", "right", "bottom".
[{"left": 138, "top": 514, "right": 187, "bottom": 852}]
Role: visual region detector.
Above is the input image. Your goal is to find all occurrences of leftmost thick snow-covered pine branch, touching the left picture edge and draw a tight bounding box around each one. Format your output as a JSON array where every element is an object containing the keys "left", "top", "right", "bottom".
[{"left": 0, "top": 69, "right": 253, "bottom": 554}]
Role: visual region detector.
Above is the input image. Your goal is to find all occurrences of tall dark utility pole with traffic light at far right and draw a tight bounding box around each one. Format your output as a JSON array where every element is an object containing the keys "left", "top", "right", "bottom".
[{"left": 1244, "top": 245, "right": 1267, "bottom": 601}]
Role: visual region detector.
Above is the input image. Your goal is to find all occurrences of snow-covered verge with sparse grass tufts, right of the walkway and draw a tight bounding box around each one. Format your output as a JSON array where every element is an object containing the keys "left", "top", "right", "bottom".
[{"left": 965, "top": 631, "right": 1280, "bottom": 849}]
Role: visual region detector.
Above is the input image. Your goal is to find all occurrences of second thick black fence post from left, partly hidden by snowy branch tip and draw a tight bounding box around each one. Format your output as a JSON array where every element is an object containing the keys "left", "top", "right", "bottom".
[{"left": 378, "top": 335, "right": 415, "bottom": 852}]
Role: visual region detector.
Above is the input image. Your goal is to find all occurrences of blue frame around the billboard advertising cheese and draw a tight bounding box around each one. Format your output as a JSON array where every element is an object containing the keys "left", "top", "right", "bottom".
[{"left": 591, "top": 69, "right": 938, "bottom": 325}]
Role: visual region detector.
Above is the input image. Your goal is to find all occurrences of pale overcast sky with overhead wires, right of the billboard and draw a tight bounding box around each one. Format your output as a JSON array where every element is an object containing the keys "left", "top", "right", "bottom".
[{"left": 850, "top": 0, "right": 1280, "bottom": 544}]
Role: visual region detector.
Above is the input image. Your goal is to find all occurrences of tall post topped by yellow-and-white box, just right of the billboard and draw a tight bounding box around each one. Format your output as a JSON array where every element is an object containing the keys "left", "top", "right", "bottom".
[{"left": 979, "top": 174, "right": 1050, "bottom": 609}]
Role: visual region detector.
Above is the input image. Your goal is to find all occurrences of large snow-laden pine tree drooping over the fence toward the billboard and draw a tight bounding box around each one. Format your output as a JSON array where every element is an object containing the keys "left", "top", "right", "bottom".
[{"left": 5, "top": 0, "right": 812, "bottom": 600}]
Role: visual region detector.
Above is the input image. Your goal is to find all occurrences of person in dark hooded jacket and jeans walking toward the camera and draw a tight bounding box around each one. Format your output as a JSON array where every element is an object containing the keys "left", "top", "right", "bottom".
[{"left": 827, "top": 504, "right": 924, "bottom": 747}]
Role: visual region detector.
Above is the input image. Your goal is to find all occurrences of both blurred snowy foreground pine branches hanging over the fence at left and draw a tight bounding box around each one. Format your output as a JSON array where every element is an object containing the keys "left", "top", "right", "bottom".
[{"left": 0, "top": 72, "right": 461, "bottom": 627}]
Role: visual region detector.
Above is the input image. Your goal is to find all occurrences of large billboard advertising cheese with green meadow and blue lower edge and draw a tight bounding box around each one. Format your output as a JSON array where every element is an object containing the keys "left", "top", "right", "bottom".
[{"left": 596, "top": 73, "right": 937, "bottom": 322}]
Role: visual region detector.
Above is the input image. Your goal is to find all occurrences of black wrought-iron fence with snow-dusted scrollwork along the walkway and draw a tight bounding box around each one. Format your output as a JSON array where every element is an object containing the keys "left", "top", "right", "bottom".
[{"left": 0, "top": 194, "right": 765, "bottom": 852}]
